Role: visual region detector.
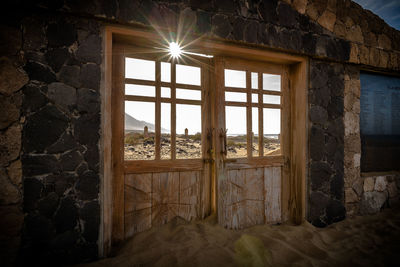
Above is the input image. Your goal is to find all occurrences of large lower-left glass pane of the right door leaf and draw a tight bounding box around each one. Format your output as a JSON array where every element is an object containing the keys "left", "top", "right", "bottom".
[{"left": 225, "top": 106, "right": 247, "bottom": 158}]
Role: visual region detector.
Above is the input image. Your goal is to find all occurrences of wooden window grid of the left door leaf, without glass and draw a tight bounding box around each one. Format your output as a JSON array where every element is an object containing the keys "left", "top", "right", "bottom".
[{"left": 112, "top": 44, "right": 210, "bottom": 173}]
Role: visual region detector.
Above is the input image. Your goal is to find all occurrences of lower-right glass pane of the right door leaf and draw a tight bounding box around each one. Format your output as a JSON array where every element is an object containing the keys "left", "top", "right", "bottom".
[{"left": 263, "top": 108, "right": 281, "bottom": 156}]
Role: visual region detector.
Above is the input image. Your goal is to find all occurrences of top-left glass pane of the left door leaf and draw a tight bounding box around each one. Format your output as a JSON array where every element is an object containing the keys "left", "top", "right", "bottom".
[{"left": 125, "top": 57, "right": 156, "bottom": 81}]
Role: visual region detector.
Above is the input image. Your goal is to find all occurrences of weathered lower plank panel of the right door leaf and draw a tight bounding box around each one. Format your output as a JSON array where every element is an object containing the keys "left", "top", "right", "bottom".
[{"left": 219, "top": 167, "right": 281, "bottom": 229}]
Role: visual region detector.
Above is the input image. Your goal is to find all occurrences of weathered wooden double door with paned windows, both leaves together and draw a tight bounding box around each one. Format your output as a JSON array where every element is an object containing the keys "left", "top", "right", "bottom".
[{"left": 112, "top": 46, "right": 291, "bottom": 240}]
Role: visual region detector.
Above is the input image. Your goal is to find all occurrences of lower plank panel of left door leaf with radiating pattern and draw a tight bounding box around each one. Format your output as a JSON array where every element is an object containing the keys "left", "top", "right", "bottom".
[{"left": 125, "top": 171, "right": 207, "bottom": 238}]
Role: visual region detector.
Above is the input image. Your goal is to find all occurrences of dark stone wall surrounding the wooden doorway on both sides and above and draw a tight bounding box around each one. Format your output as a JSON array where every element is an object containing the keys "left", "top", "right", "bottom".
[{"left": 0, "top": 0, "right": 400, "bottom": 264}]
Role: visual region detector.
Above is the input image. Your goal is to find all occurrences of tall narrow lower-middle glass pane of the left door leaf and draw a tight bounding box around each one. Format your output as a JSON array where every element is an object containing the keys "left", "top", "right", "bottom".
[{"left": 161, "top": 103, "right": 171, "bottom": 159}]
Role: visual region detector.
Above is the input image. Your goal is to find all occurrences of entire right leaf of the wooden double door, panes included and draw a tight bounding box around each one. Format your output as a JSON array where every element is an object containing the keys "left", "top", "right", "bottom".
[{"left": 214, "top": 57, "right": 290, "bottom": 229}]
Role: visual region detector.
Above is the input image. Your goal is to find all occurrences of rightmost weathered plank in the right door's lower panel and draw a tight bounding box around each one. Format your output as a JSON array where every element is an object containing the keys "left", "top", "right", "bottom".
[{"left": 264, "top": 167, "right": 282, "bottom": 223}]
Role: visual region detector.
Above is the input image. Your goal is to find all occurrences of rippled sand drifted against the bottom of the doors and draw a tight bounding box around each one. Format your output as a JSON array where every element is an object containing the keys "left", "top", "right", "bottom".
[{"left": 76, "top": 208, "right": 400, "bottom": 267}]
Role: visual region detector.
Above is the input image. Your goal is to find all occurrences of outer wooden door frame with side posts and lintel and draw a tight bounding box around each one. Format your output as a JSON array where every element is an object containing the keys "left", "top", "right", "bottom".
[{"left": 98, "top": 26, "right": 308, "bottom": 256}]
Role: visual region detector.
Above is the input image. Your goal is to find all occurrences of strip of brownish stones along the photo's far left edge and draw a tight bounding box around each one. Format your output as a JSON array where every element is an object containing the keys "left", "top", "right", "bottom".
[{"left": 0, "top": 25, "right": 28, "bottom": 266}]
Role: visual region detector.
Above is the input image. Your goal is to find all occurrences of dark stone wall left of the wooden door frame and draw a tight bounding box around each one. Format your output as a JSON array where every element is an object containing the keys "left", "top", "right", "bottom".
[{"left": 0, "top": 12, "right": 102, "bottom": 266}]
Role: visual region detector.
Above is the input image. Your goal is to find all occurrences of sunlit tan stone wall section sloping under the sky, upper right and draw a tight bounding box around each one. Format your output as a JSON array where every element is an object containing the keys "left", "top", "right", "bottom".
[{"left": 285, "top": 0, "right": 400, "bottom": 70}]
